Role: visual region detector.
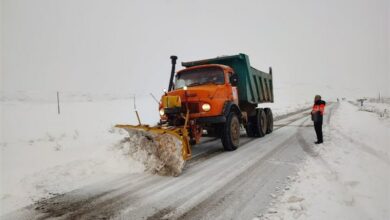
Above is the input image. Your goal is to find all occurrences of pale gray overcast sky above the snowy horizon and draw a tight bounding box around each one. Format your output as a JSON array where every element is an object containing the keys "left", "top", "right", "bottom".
[{"left": 1, "top": 0, "right": 390, "bottom": 101}]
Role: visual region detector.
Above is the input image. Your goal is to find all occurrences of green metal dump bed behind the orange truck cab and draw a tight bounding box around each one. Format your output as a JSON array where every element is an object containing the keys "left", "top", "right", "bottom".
[{"left": 182, "top": 53, "right": 274, "bottom": 104}]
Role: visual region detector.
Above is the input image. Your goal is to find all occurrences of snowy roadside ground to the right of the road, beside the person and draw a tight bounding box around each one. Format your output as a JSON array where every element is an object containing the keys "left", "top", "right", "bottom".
[{"left": 255, "top": 101, "right": 390, "bottom": 220}]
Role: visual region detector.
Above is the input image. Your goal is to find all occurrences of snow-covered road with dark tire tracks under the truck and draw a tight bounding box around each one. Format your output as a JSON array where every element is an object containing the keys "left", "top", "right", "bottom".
[{"left": 2, "top": 105, "right": 337, "bottom": 219}]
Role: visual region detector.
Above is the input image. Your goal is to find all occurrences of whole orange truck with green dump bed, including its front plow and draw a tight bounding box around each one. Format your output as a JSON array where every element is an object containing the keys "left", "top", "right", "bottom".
[{"left": 116, "top": 53, "right": 274, "bottom": 175}]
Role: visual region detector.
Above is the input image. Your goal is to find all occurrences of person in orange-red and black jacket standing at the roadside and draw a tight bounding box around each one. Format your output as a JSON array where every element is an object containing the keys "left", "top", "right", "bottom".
[{"left": 311, "top": 95, "right": 326, "bottom": 144}]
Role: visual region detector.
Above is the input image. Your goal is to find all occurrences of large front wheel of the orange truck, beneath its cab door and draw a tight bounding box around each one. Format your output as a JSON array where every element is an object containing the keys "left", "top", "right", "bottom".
[{"left": 221, "top": 112, "right": 240, "bottom": 151}]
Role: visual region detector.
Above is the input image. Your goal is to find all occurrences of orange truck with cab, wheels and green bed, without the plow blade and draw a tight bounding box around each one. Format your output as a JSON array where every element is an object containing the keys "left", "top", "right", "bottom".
[{"left": 159, "top": 54, "right": 273, "bottom": 151}]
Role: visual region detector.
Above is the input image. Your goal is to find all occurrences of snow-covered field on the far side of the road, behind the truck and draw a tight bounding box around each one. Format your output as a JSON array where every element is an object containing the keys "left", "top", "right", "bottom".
[{"left": 0, "top": 92, "right": 311, "bottom": 214}]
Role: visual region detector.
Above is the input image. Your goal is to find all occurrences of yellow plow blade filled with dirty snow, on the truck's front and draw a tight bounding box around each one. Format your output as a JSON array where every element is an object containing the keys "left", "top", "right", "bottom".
[{"left": 115, "top": 125, "right": 191, "bottom": 176}]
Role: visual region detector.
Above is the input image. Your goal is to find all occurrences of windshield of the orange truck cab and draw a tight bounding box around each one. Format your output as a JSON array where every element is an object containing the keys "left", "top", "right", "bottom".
[{"left": 175, "top": 67, "right": 225, "bottom": 89}]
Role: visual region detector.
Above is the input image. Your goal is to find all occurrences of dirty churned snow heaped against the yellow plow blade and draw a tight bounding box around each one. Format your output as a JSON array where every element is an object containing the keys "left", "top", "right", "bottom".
[{"left": 115, "top": 129, "right": 185, "bottom": 176}]
